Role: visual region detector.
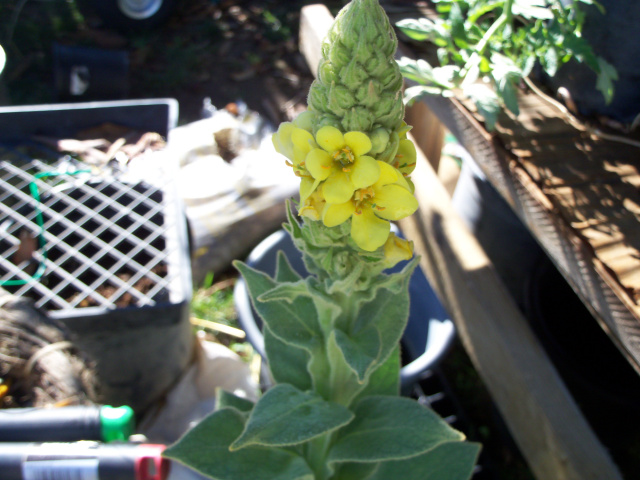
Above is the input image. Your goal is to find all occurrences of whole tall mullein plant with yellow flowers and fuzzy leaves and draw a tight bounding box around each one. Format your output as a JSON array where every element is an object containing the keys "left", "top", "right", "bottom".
[{"left": 165, "top": 0, "right": 480, "bottom": 480}]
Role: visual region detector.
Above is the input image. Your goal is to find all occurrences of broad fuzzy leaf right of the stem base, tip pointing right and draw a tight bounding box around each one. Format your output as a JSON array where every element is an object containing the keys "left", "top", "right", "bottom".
[{"left": 329, "top": 396, "right": 464, "bottom": 464}]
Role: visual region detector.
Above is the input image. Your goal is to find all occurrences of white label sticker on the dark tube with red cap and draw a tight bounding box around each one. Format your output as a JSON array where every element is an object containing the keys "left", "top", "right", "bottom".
[{"left": 22, "top": 458, "right": 98, "bottom": 480}]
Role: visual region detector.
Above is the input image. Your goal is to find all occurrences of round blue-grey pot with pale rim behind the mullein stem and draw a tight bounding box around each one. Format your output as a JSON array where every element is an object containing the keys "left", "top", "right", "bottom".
[{"left": 234, "top": 227, "right": 455, "bottom": 391}]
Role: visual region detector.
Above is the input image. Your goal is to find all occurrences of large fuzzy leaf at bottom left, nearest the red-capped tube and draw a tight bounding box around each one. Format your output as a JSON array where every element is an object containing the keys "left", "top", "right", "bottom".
[{"left": 163, "top": 408, "right": 315, "bottom": 480}]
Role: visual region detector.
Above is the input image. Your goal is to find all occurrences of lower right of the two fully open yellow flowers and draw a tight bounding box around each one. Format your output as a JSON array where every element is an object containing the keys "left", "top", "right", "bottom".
[{"left": 322, "top": 161, "right": 418, "bottom": 252}]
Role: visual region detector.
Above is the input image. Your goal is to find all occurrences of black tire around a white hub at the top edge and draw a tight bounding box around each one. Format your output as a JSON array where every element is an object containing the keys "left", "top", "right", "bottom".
[{"left": 77, "top": 0, "right": 176, "bottom": 33}]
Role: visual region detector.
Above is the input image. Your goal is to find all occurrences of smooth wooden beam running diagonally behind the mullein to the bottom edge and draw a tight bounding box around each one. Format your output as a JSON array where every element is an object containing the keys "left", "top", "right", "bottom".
[{"left": 300, "top": 6, "right": 622, "bottom": 480}]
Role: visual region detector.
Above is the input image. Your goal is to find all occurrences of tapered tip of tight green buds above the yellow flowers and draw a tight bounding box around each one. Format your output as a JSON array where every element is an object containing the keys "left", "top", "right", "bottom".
[{"left": 309, "top": 0, "right": 404, "bottom": 134}]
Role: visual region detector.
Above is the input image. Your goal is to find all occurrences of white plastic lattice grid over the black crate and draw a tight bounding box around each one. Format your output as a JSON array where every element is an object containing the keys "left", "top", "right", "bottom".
[{"left": 0, "top": 143, "right": 177, "bottom": 311}]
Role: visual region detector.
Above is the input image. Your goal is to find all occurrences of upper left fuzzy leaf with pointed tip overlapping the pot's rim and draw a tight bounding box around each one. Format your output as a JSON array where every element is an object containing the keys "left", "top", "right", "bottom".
[{"left": 234, "top": 262, "right": 320, "bottom": 349}]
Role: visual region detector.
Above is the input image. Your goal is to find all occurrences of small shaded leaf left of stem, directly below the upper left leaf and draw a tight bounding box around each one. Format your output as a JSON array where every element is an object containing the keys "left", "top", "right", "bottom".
[{"left": 262, "top": 327, "right": 313, "bottom": 391}]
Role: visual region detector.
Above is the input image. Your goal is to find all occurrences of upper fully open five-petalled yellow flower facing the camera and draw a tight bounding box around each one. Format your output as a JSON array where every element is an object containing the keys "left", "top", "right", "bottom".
[{"left": 305, "top": 126, "right": 380, "bottom": 203}]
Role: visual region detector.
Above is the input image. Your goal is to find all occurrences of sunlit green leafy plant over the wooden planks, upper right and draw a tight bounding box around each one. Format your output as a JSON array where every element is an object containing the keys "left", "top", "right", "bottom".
[{"left": 397, "top": 0, "right": 617, "bottom": 130}]
